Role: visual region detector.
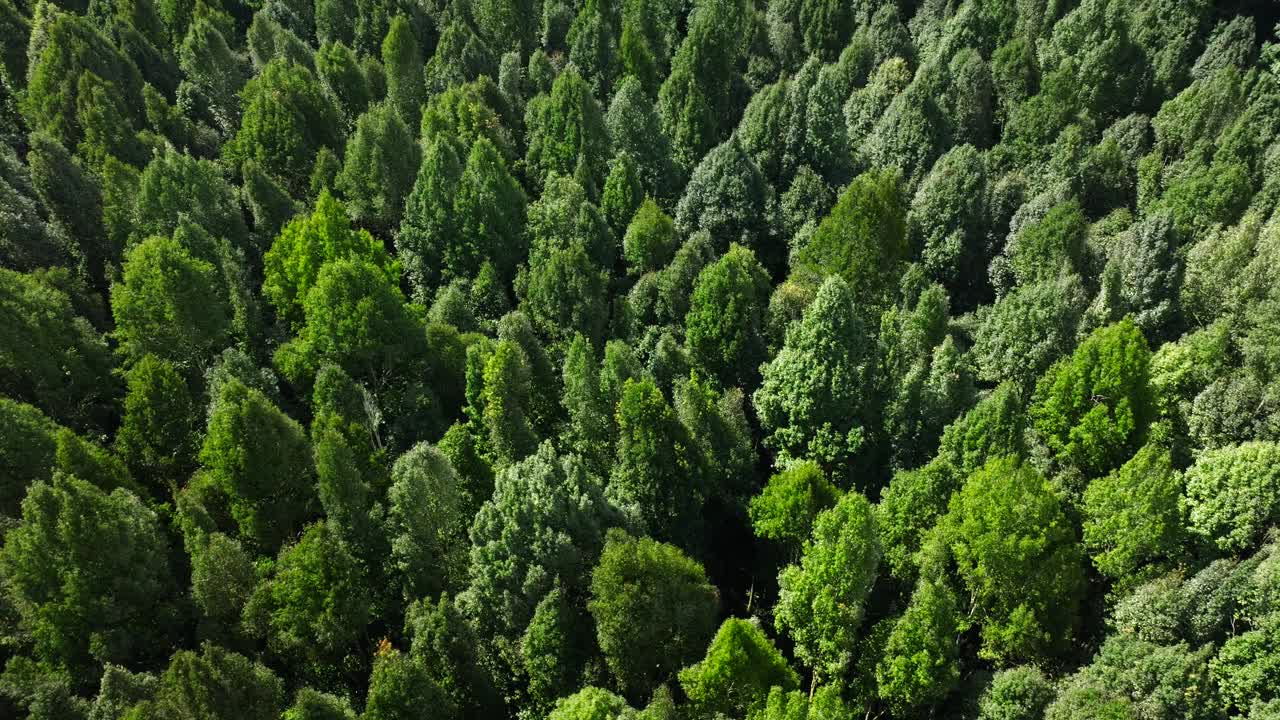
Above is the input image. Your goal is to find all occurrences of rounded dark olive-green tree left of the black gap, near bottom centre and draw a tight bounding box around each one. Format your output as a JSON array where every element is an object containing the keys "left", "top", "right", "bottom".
[{"left": 588, "top": 529, "right": 719, "bottom": 698}]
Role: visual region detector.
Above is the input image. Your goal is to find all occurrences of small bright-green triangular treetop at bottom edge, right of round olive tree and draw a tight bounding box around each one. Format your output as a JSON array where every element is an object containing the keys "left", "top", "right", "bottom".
[{"left": 680, "top": 618, "right": 800, "bottom": 717}]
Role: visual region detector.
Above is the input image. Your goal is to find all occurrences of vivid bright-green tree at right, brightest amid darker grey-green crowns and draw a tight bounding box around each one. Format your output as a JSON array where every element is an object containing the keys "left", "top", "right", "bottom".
[{"left": 1028, "top": 319, "right": 1151, "bottom": 478}]
